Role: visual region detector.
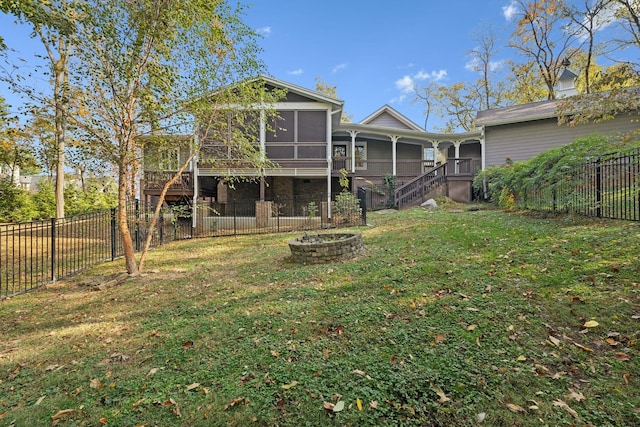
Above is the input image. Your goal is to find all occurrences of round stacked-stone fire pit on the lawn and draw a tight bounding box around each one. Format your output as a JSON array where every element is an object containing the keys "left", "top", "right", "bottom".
[{"left": 289, "top": 233, "right": 364, "bottom": 264}]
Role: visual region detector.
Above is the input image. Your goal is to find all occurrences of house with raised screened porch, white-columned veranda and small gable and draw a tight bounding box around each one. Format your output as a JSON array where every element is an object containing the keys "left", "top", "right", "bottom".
[{"left": 141, "top": 76, "right": 482, "bottom": 217}]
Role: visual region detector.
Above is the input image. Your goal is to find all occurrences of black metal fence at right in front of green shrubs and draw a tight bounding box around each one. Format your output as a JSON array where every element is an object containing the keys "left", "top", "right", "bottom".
[{"left": 516, "top": 149, "right": 640, "bottom": 221}]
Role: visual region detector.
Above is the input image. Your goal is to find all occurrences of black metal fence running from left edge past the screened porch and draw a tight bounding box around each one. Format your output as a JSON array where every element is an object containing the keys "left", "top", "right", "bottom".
[{"left": 0, "top": 195, "right": 366, "bottom": 300}]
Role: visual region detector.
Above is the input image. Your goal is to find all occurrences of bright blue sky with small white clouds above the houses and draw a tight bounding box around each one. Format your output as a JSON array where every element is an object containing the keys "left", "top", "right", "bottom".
[{"left": 0, "top": 0, "right": 636, "bottom": 130}]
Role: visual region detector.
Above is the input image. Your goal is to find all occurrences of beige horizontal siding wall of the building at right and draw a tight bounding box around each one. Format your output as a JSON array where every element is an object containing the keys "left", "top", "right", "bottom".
[{"left": 485, "top": 115, "right": 640, "bottom": 166}]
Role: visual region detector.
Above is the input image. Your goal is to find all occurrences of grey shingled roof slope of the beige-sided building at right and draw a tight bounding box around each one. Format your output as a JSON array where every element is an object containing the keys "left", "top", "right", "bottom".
[{"left": 475, "top": 100, "right": 557, "bottom": 126}]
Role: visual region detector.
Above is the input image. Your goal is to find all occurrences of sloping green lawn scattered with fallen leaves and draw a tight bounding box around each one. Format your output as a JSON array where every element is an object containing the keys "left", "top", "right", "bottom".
[{"left": 0, "top": 209, "right": 640, "bottom": 426}]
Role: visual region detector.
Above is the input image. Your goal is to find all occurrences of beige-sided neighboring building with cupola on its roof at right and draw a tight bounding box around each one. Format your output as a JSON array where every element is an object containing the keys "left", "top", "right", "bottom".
[{"left": 475, "top": 70, "right": 640, "bottom": 169}]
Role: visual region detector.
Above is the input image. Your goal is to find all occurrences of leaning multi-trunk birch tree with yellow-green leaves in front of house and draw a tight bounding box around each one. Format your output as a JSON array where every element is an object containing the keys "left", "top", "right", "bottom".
[{"left": 67, "top": 0, "right": 278, "bottom": 274}]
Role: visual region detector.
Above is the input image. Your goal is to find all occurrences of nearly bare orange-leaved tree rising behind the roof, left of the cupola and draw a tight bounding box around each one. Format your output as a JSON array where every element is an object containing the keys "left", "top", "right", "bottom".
[{"left": 509, "top": 0, "right": 576, "bottom": 99}]
